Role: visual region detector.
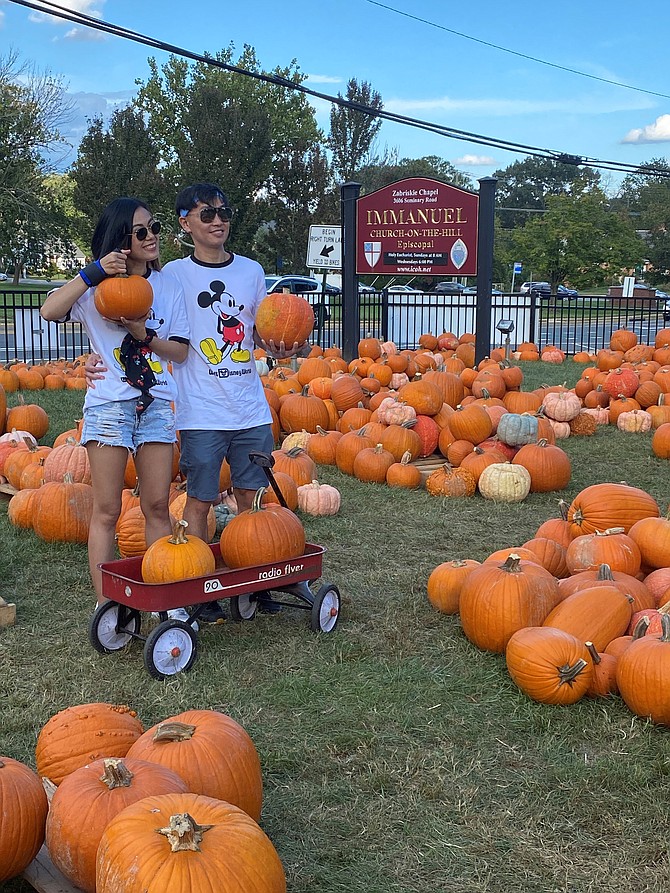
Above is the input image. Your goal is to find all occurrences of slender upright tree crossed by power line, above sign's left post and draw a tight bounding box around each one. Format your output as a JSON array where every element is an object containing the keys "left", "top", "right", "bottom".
[{"left": 328, "top": 78, "right": 384, "bottom": 183}]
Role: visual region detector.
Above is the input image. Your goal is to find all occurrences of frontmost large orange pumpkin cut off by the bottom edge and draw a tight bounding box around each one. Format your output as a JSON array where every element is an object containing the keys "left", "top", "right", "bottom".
[{"left": 96, "top": 794, "right": 286, "bottom": 893}]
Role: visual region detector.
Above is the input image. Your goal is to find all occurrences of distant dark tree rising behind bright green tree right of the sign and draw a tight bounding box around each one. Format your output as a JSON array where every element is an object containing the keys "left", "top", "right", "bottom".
[{"left": 493, "top": 157, "right": 600, "bottom": 229}]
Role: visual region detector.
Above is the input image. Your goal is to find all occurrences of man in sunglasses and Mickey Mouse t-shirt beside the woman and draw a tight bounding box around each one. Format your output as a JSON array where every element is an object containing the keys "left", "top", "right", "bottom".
[{"left": 163, "top": 183, "right": 299, "bottom": 622}]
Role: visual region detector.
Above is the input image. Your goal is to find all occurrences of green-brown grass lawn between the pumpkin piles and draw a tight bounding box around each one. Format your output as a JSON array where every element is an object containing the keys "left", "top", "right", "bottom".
[{"left": 0, "top": 363, "right": 670, "bottom": 893}]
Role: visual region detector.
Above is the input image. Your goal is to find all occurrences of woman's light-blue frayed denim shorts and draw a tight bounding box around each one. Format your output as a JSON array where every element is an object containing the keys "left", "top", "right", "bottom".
[{"left": 81, "top": 399, "right": 177, "bottom": 452}]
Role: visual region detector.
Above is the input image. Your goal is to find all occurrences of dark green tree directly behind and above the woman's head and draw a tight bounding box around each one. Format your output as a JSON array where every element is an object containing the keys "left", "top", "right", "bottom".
[{"left": 70, "top": 107, "right": 167, "bottom": 242}]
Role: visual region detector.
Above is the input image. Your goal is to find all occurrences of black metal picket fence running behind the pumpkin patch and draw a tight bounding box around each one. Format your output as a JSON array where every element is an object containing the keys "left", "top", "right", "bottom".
[{"left": 0, "top": 290, "right": 670, "bottom": 363}]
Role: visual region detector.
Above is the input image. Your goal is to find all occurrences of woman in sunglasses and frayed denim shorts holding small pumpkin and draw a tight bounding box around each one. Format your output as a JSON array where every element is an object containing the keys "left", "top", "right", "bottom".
[{"left": 41, "top": 198, "right": 189, "bottom": 619}]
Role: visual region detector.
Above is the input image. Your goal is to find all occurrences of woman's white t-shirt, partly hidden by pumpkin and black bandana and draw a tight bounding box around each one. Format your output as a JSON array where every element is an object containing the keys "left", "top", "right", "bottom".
[{"left": 67, "top": 270, "right": 189, "bottom": 408}]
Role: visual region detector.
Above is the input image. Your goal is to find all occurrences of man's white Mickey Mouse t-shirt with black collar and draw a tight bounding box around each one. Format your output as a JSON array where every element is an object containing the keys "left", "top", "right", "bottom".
[{"left": 163, "top": 255, "right": 272, "bottom": 431}]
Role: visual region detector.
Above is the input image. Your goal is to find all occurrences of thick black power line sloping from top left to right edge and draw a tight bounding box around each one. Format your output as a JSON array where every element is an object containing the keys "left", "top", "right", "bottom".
[{"left": 9, "top": 0, "right": 670, "bottom": 177}]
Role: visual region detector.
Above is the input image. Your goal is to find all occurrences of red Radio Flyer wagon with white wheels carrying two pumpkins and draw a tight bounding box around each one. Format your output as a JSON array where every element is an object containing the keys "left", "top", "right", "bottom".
[{"left": 89, "top": 543, "right": 340, "bottom": 679}]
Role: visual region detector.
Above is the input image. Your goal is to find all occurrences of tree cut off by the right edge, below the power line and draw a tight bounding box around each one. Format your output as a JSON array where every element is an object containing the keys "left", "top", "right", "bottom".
[{"left": 614, "top": 158, "right": 670, "bottom": 285}]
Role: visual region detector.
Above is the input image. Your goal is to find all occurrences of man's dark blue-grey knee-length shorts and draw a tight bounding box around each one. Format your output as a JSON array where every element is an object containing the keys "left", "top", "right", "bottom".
[{"left": 179, "top": 425, "right": 274, "bottom": 502}]
